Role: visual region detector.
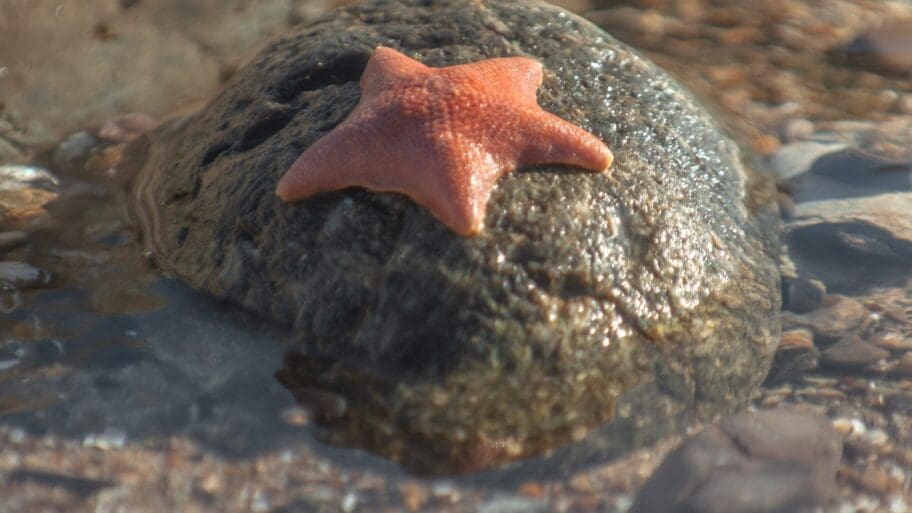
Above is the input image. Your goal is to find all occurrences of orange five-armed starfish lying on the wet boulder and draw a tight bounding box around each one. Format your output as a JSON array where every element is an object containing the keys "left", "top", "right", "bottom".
[{"left": 276, "top": 46, "right": 613, "bottom": 236}]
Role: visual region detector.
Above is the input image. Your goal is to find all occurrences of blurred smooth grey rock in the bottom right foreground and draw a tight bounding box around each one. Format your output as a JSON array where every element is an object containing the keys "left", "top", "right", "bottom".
[{"left": 631, "top": 409, "right": 842, "bottom": 513}]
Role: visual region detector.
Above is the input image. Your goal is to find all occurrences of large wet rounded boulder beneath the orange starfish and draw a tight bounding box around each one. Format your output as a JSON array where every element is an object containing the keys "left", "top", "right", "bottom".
[{"left": 126, "top": 0, "right": 779, "bottom": 471}]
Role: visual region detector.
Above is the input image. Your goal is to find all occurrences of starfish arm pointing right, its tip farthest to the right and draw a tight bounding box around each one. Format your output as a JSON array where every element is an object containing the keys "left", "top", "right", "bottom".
[{"left": 518, "top": 110, "right": 614, "bottom": 172}]
